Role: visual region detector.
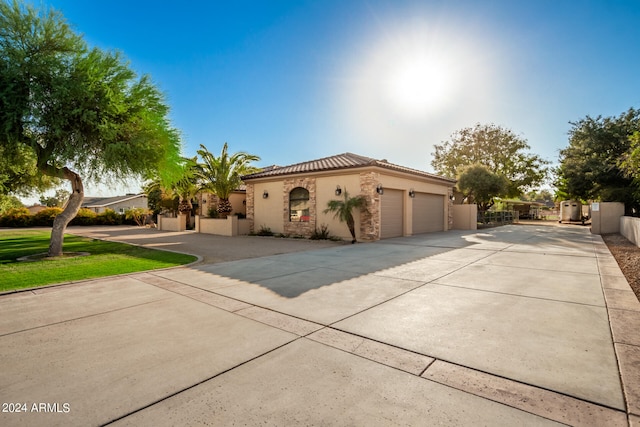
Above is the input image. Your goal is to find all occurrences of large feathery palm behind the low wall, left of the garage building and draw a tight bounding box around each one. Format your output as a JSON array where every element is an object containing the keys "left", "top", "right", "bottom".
[{"left": 197, "top": 142, "right": 260, "bottom": 218}]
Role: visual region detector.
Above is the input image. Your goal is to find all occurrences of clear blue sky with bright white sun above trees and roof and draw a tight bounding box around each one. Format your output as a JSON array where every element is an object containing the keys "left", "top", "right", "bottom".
[{"left": 38, "top": 0, "right": 640, "bottom": 193}]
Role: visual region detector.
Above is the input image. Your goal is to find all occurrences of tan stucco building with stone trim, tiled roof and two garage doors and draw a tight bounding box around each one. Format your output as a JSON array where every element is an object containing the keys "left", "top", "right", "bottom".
[{"left": 243, "top": 153, "right": 456, "bottom": 240}]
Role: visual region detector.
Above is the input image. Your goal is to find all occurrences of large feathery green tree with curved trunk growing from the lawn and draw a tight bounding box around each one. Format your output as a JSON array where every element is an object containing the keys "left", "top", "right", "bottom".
[{"left": 0, "top": 1, "right": 180, "bottom": 256}]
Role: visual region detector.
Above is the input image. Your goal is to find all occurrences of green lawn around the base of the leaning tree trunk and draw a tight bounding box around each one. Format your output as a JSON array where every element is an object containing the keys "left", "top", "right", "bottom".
[{"left": 0, "top": 230, "right": 196, "bottom": 292}]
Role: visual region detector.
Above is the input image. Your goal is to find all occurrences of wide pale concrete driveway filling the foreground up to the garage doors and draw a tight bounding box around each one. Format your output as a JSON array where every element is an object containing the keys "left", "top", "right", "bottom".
[{"left": 0, "top": 225, "right": 640, "bottom": 426}]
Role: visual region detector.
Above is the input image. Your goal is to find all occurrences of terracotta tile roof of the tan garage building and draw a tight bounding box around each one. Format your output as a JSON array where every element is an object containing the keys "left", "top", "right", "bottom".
[{"left": 242, "top": 153, "right": 456, "bottom": 183}]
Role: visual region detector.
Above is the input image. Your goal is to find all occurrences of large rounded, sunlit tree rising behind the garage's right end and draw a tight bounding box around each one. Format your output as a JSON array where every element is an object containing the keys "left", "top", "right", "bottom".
[{"left": 431, "top": 124, "right": 549, "bottom": 197}]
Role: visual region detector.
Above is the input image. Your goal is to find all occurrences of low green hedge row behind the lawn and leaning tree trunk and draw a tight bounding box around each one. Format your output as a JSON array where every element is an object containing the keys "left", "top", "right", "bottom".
[{"left": 0, "top": 208, "right": 135, "bottom": 227}]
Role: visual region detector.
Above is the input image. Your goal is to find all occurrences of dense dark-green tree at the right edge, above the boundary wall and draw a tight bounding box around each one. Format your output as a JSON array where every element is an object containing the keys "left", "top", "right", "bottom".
[{"left": 556, "top": 108, "right": 640, "bottom": 213}]
